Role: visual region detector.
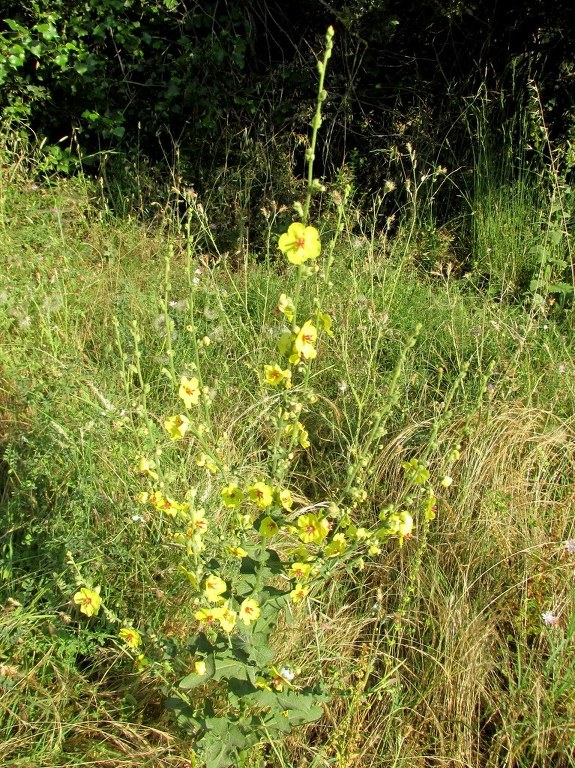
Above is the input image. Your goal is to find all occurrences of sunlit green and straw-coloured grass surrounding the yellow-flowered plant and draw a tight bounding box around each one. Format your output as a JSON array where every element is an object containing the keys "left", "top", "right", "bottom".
[{"left": 0, "top": 114, "right": 575, "bottom": 768}]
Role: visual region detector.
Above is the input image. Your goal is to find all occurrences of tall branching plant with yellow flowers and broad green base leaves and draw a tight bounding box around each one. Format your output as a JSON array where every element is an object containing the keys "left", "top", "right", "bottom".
[{"left": 117, "top": 29, "right": 454, "bottom": 768}]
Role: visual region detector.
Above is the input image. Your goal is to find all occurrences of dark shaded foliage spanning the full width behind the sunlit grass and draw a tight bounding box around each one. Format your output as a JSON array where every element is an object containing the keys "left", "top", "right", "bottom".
[{"left": 0, "top": 0, "right": 575, "bottom": 201}]
